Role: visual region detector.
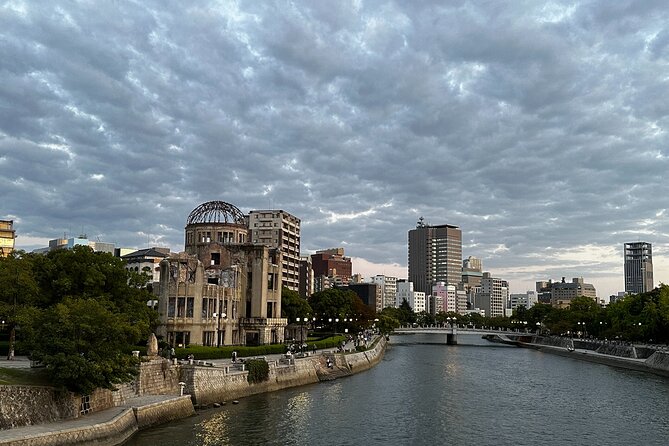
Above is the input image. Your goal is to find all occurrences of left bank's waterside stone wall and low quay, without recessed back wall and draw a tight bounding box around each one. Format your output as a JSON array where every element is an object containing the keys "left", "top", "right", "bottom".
[{"left": 0, "top": 337, "right": 387, "bottom": 446}]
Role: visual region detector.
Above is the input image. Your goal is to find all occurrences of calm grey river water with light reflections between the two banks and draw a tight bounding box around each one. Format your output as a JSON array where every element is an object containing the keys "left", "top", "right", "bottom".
[{"left": 127, "top": 335, "right": 669, "bottom": 446}]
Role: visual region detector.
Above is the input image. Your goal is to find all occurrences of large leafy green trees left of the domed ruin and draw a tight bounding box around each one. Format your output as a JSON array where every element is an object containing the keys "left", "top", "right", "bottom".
[{"left": 0, "top": 246, "right": 157, "bottom": 393}]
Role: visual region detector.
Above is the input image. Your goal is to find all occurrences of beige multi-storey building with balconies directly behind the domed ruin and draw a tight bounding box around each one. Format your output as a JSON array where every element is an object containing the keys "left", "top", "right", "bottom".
[{"left": 249, "top": 210, "right": 300, "bottom": 291}]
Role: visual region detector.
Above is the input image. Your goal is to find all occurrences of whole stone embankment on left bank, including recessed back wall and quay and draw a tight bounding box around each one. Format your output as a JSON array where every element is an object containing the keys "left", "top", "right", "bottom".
[{"left": 0, "top": 337, "right": 387, "bottom": 446}]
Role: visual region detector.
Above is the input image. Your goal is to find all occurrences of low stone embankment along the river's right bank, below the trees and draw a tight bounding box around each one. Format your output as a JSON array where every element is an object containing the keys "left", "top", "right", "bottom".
[{"left": 519, "top": 336, "right": 669, "bottom": 376}]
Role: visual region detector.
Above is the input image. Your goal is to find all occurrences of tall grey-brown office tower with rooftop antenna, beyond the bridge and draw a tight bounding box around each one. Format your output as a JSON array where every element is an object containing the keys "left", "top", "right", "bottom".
[{"left": 409, "top": 217, "right": 462, "bottom": 294}]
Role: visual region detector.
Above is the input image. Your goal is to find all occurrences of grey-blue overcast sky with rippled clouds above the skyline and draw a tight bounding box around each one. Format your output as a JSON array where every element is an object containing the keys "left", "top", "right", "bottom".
[{"left": 0, "top": 0, "right": 669, "bottom": 297}]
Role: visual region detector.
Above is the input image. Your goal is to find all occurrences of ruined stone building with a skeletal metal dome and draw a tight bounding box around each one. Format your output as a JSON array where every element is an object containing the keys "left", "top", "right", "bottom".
[{"left": 157, "top": 201, "right": 287, "bottom": 346}]
